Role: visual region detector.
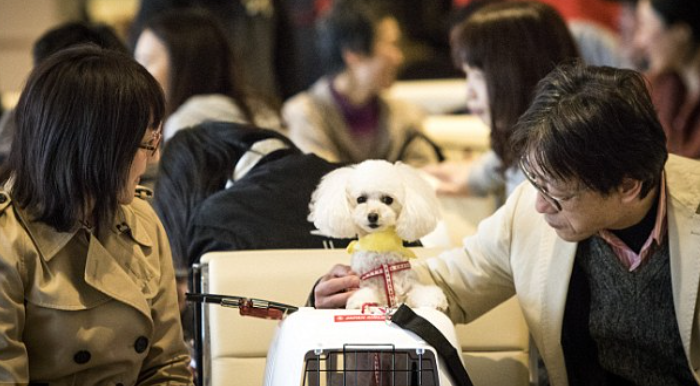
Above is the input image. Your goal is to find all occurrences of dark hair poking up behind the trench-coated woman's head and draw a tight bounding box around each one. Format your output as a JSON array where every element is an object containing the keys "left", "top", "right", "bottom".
[{"left": 32, "top": 22, "right": 129, "bottom": 66}]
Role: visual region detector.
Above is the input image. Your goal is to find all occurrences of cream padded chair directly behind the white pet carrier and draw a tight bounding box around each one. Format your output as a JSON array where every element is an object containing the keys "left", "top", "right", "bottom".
[{"left": 193, "top": 248, "right": 529, "bottom": 386}]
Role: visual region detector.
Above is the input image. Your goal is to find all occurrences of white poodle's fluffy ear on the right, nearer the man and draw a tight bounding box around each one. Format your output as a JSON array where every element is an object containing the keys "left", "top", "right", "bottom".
[{"left": 395, "top": 162, "right": 440, "bottom": 241}]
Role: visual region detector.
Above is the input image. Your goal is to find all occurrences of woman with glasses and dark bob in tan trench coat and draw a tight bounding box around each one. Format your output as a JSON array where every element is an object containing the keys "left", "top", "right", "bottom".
[{"left": 0, "top": 46, "right": 192, "bottom": 385}]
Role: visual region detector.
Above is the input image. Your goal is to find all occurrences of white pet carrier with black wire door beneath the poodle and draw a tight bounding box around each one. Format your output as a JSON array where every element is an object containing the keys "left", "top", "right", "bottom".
[{"left": 264, "top": 308, "right": 462, "bottom": 386}]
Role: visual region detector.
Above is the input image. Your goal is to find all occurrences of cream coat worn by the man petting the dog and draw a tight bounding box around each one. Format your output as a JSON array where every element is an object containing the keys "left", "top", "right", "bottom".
[{"left": 414, "top": 156, "right": 700, "bottom": 386}]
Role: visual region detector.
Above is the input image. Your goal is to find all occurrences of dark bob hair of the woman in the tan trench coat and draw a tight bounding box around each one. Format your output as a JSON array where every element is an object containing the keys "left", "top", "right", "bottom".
[{"left": 4, "top": 45, "right": 164, "bottom": 232}]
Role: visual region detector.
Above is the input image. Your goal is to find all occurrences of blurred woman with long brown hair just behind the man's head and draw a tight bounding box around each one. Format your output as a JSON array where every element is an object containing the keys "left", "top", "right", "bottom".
[{"left": 426, "top": 1, "right": 579, "bottom": 201}]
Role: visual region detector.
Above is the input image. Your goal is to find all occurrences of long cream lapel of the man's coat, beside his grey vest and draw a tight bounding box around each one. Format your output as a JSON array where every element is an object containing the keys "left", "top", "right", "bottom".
[{"left": 538, "top": 229, "right": 577, "bottom": 384}]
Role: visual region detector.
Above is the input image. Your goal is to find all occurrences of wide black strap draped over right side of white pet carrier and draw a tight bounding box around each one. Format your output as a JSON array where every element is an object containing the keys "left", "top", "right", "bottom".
[{"left": 391, "top": 304, "right": 474, "bottom": 386}]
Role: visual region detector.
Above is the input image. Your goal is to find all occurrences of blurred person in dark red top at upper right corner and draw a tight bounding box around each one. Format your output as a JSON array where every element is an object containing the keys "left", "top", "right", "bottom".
[{"left": 634, "top": 0, "right": 700, "bottom": 158}]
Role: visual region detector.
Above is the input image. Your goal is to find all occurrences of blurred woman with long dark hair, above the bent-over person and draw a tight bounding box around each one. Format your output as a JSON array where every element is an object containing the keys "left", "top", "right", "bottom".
[{"left": 134, "top": 9, "right": 281, "bottom": 142}]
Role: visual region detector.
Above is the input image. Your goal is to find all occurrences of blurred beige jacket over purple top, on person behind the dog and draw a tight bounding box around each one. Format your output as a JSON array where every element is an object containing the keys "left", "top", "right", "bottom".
[{"left": 282, "top": 78, "right": 437, "bottom": 167}]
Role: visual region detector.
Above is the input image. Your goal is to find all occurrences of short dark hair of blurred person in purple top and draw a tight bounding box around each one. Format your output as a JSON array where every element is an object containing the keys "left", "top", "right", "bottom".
[{"left": 316, "top": 0, "right": 390, "bottom": 75}]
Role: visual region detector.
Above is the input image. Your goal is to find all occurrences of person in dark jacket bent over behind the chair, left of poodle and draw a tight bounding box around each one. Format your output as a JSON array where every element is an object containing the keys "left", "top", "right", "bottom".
[{"left": 153, "top": 122, "right": 348, "bottom": 270}]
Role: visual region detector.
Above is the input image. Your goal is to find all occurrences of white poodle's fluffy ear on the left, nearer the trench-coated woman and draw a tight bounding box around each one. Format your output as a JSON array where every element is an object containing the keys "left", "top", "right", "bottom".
[{"left": 308, "top": 166, "right": 357, "bottom": 238}]
